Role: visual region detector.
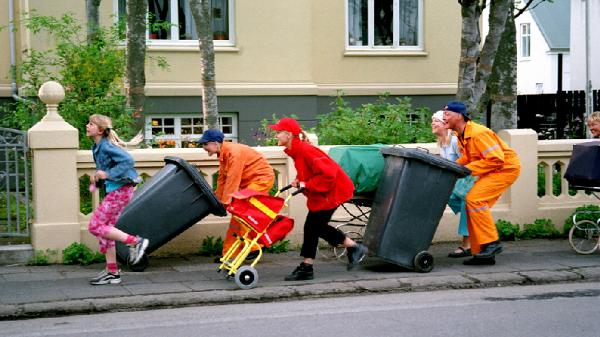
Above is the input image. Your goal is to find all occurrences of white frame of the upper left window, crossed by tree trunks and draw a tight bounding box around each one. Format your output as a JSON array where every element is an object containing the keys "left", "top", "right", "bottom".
[{"left": 112, "top": 0, "right": 235, "bottom": 47}]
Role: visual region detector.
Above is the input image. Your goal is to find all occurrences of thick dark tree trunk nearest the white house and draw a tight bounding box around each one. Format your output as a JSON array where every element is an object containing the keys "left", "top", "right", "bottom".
[{"left": 487, "top": 8, "right": 517, "bottom": 131}]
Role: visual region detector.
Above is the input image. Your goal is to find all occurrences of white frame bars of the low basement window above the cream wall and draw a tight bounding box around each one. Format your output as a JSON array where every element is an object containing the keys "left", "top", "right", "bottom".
[{"left": 144, "top": 112, "right": 239, "bottom": 147}]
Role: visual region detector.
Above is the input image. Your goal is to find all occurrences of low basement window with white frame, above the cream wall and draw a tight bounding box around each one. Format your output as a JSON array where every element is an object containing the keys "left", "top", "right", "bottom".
[{"left": 145, "top": 113, "right": 238, "bottom": 147}]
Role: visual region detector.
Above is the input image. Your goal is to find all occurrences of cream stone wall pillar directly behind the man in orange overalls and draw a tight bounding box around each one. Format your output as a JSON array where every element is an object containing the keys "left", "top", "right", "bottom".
[{"left": 498, "top": 129, "right": 538, "bottom": 224}]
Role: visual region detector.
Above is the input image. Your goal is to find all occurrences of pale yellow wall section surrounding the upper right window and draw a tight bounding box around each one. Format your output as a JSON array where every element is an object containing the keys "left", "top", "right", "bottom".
[{"left": 312, "top": 0, "right": 461, "bottom": 94}]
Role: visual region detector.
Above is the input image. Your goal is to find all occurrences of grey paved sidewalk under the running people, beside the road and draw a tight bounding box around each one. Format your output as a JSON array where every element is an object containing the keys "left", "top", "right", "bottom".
[{"left": 0, "top": 240, "right": 600, "bottom": 320}]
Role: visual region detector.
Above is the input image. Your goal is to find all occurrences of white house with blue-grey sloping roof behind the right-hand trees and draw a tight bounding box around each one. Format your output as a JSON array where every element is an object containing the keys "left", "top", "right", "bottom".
[{"left": 515, "top": 0, "right": 568, "bottom": 95}]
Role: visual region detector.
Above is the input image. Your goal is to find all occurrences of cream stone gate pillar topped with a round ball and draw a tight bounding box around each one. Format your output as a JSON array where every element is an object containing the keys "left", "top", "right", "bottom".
[{"left": 28, "top": 81, "right": 81, "bottom": 258}]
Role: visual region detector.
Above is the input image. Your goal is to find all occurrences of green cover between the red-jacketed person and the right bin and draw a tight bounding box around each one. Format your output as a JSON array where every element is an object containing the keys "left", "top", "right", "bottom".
[{"left": 329, "top": 144, "right": 385, "bottom": 193}]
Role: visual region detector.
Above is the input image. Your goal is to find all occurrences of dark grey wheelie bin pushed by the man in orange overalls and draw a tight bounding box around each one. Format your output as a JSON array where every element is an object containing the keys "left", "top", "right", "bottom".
[{"left": 364, "top": 147, "right": 470, "bottom": 272}]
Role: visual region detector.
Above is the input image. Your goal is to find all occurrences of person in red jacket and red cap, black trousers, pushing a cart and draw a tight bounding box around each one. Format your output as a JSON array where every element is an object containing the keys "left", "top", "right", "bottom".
[{"left": 269, "top": 118, "right": 367, "bottom": 281}]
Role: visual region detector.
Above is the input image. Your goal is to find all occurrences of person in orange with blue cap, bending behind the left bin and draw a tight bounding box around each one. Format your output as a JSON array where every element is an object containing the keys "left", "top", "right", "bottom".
[{"left": 200, "top": 129, "right": 275, "bottom": 262}]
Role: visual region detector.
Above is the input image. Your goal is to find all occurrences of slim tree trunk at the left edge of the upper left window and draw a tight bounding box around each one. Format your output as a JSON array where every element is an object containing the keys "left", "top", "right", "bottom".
[{"left": 126, "top": 0, "right": 148, "bottom": 128}]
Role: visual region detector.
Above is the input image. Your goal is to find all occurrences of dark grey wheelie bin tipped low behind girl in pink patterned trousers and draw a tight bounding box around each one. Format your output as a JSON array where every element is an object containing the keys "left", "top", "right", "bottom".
[{"left": 116, "top": 157, "right": 227, "bottom": 271}]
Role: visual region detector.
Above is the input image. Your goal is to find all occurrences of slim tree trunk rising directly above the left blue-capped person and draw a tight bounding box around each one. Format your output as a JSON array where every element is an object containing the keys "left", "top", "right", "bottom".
[{"left": 189, "top": 0, "right": 219, "bottom": 129}]
